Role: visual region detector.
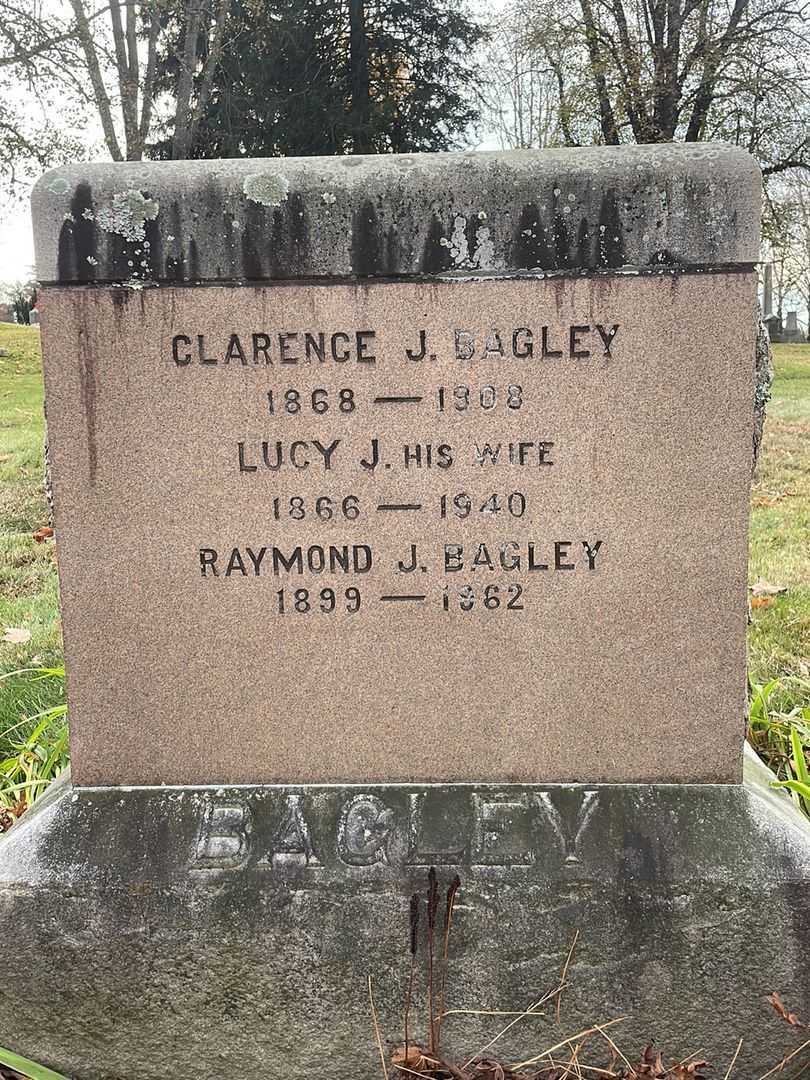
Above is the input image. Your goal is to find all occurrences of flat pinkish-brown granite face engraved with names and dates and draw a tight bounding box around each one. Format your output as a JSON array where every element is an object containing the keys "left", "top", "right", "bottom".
[{"left": 41, "top": 272, "right": 756, "bottom": 784}]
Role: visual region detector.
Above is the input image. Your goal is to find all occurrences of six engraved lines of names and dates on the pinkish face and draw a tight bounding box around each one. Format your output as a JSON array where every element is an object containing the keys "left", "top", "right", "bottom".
[{"left": 171, "top": 322, "right": 620, "bottom": 615}]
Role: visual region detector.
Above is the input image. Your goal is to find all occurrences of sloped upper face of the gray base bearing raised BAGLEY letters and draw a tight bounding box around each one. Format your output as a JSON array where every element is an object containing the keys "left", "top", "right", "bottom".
[{"left": 0, "top": 753, "right": 810, "bottom": 891}]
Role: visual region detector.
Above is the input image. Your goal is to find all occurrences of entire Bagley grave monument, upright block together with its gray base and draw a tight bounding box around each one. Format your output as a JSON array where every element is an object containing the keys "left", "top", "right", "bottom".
[{"left": 0, "top": 146, "right": 810, "bottom": 1080}]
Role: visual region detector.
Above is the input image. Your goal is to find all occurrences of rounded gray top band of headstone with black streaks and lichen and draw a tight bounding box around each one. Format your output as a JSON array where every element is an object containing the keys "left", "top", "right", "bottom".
[{"left": 32, "top": 144, "right": 760, "bottom": 284}]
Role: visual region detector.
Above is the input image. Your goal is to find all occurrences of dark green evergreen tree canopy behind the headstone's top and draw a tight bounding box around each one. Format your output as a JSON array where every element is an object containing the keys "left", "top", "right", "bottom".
[{"left": 151, "top": 0, "right": 484, "bottom": 158}]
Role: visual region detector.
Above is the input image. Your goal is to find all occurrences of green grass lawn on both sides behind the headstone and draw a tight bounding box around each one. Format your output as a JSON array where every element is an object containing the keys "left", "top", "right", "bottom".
[{"left": 0, "top": 323, "right": 810, "bottom": 812}]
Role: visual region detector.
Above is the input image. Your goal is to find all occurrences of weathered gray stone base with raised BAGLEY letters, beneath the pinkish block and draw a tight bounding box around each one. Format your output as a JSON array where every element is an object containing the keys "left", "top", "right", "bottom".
[{"left": 0, "top": 751, "right": 810, "bottom": 1080}]
